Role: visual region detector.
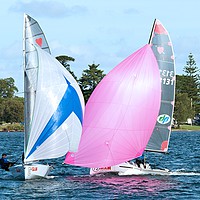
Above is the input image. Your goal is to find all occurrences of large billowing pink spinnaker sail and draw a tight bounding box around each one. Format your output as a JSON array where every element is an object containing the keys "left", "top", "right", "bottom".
[{"left": 65, "top": 45, "right": 161, "bottom": 168}]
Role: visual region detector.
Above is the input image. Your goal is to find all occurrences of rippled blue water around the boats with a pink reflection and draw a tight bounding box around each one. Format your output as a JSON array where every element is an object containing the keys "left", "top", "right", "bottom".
[{"left": 0, "top": 131, "right": 200, "bottom": 200}]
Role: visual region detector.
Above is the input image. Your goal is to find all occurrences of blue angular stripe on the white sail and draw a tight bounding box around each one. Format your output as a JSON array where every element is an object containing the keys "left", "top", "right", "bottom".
[{"left": 26, "top": 78, "right": 83, "bottom": 159}]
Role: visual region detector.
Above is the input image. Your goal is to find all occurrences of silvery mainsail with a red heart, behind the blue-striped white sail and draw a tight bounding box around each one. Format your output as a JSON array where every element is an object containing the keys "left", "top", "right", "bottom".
[{"left": 23, "top": 14, "right": 50, "bottom": 155}]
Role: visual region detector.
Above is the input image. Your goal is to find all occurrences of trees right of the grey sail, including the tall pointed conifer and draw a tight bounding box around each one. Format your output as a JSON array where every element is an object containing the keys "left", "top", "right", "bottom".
[{"left": 174, "top": 53, "right": 200, "bottom": 124}]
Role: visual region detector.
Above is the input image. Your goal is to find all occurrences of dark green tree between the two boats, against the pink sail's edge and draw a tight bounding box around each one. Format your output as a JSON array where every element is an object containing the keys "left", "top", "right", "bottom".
[{"left": 79, "top": 64, "right": 105, "bottom": 102}]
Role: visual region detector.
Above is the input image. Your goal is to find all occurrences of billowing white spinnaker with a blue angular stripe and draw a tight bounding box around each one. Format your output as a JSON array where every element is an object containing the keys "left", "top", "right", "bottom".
[{"left": 25, "top": 47, "right": 84, "bottom": 162}]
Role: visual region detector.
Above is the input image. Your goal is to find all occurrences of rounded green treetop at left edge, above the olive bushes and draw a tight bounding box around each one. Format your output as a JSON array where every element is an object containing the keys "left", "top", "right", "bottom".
[{"left": 0, "top": 77, "right": 18, "bottom": 98}]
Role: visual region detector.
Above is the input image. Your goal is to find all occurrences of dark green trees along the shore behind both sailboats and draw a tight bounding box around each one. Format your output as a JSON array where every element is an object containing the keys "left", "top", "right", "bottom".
[{"left": 0, "top": 53, "right": 200, "bottom": 123}]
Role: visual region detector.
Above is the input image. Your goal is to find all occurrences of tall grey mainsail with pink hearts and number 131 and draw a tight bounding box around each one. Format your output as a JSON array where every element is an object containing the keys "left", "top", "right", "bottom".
[{"left": 146, "top": 19, "right": 175, "bottom": 152}]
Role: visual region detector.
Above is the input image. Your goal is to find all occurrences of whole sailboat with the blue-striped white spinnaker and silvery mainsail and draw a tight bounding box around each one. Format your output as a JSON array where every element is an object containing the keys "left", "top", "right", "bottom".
[{"left": 10, "top": 14, "right": 84, "bottom": 180}]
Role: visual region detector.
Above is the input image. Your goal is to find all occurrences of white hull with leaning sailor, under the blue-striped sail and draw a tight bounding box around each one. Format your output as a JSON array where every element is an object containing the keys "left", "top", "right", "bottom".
[{"left": 10, "top": 163, "right": 52, "bottom": 180}]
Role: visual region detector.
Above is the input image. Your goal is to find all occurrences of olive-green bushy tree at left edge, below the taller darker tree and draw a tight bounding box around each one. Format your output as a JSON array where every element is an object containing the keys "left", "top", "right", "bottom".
[{"left": 0, "top": 97, "right": 24, "bottom": 123}]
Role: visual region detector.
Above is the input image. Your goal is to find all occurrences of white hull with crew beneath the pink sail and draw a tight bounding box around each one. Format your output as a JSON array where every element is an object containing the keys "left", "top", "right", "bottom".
[{"left": 90, "top": 162, "right": 170, "bottom": 176}]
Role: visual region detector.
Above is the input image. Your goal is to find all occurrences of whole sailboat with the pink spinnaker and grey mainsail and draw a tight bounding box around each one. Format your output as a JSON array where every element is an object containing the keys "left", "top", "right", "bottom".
[{"left": 65, "top": 20, "right": 175, "bottom": 175}]
